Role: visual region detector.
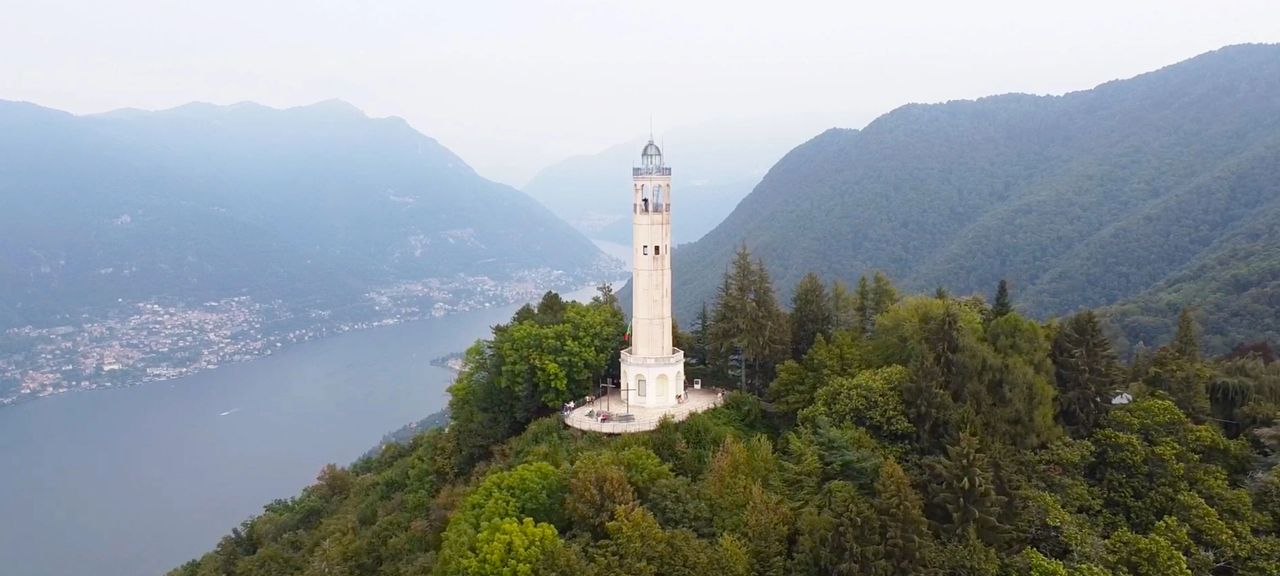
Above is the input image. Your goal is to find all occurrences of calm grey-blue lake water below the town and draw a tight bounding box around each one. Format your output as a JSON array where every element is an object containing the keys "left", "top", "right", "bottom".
[{"left": 0, "top": 284, "right": 595, "bottom": 576}]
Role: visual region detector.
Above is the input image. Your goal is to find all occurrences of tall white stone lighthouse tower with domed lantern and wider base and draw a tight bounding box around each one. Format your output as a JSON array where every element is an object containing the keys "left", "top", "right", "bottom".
[{"left": 622, "top": 138, "right": 685, "bottom": 408}]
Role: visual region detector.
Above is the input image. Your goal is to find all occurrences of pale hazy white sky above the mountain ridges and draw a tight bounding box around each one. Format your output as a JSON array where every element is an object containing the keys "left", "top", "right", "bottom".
[{"left": 0, "top": 0, "right": 1280, "bottom": 186}]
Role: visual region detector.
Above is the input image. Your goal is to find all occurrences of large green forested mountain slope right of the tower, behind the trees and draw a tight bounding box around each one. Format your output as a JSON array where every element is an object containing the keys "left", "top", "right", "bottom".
[{"left": 675, "top": 45, "right": 1280, "bottom": 349}]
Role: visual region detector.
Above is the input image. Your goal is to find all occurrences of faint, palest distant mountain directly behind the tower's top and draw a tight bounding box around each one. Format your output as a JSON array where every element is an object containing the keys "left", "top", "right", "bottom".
[{"left": 524, "top": 122, "right": 808, "bottom": 243}]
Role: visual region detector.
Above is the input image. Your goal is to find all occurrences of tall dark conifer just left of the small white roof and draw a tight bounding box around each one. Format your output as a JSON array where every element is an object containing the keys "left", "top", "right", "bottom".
[{"left": 1050, "top": 311, "right": 1121, "bottom": 438}]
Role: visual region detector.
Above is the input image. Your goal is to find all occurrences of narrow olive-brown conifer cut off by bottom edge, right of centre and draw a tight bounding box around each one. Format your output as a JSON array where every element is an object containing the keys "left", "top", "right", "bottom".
[{"left": 876, "top": 460, "right": 929, "bottom": 576}]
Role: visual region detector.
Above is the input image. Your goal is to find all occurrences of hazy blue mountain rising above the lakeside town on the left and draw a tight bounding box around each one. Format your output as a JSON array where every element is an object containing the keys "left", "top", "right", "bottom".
[{"left": 0, "top": 96, "right": 603, "bottom": 326}]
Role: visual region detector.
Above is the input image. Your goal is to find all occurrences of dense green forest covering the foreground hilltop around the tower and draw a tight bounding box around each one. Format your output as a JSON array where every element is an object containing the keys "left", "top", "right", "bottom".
[{"left": 172, "top": 248, "right": 1280, "bottom": 576}]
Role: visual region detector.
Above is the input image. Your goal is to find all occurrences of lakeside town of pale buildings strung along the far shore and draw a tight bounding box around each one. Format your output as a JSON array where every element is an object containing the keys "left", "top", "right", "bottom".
[{"left": 0, "top": 269, "right": 606, "bottom": 406}]
